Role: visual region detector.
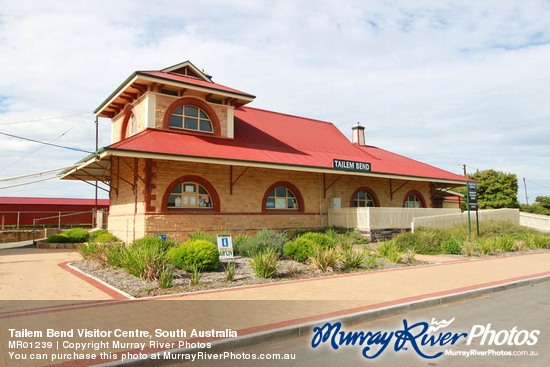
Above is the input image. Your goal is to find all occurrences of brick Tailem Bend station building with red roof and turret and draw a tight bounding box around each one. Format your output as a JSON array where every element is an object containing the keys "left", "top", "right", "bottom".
[{"left": 62, "top": 61, "right": 467, "bottom": 240}]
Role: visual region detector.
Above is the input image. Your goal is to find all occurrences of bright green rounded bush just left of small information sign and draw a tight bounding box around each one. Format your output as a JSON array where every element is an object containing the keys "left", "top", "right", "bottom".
[{"left": 168, "top": 240, "right": 220, "bottom": 271}]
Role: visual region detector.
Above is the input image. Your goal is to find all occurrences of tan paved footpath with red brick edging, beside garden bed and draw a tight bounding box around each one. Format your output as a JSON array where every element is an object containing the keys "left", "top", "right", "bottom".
[{"left": 0, "top": 249, "right": 550, "bottom": 366}]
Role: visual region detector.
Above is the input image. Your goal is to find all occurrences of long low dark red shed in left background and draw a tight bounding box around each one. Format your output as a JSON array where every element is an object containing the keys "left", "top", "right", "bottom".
[{"left": 0, "top": 197, "right": 109, "bottom": 227}]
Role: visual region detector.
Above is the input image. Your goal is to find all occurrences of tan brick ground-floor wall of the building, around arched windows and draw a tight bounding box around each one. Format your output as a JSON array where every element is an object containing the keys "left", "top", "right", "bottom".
[{"left": 109, "top": 158, "right": 431, "bottom": 241}]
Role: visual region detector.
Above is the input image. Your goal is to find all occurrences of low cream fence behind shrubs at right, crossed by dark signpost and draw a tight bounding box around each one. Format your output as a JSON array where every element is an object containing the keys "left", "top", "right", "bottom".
[{"left": 411, "top": 209, "right": 519, "bottom": 232}]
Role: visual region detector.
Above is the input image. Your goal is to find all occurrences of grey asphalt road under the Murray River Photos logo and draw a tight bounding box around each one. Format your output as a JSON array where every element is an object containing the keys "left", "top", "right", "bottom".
[{"left": 181, "top": 282, "right": 550, "bottom": 367}]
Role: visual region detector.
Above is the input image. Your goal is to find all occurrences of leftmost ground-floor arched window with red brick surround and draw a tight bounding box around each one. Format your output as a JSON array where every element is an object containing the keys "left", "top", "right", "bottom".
[{"left": 162, "top": 175, "right": 220, "bottom": 212}]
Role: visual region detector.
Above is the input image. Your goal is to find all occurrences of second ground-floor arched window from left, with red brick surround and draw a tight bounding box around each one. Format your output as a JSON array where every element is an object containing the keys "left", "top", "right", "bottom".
[{"left": 262, "top": 182, "right": 304, "bottom": 213}]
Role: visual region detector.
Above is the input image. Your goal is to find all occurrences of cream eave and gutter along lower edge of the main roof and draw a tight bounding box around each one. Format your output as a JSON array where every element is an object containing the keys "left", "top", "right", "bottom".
[{"left": 60, "top": 148, "right": 468, "bottom": 186}]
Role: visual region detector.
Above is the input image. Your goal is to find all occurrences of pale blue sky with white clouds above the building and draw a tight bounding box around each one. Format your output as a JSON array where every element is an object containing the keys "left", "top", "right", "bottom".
[{"left": 0, "top": 0, "right": 550, "bottom": 203}]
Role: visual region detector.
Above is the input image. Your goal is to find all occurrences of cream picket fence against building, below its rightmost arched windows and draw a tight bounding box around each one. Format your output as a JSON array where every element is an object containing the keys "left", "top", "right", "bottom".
[{"left": 328, "top": 208, "right": 460, "bottom": 231}]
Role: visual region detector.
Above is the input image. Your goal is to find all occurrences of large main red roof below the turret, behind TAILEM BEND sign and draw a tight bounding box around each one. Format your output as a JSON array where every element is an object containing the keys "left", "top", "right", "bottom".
[{"left": 107, "top": 107, "right": 466, "bottom": 181}]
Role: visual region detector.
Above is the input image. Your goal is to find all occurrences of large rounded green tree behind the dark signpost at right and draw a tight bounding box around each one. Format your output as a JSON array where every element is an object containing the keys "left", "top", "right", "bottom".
[{"left": 467, "top": 169, "right": 519, "bottom": 209}]
